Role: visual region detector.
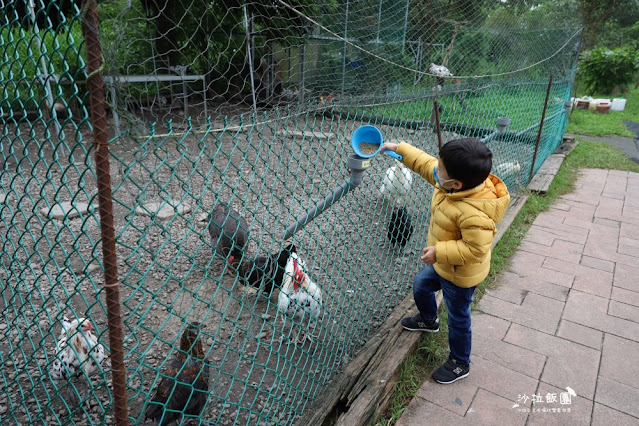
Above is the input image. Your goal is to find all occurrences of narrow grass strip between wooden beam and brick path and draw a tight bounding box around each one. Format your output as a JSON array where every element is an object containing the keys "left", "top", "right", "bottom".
[{"left": 375, "top": 141, "right": 639, "bottom": 426}]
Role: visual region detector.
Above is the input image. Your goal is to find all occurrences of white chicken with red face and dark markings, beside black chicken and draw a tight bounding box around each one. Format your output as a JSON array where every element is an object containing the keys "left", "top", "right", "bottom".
[{"left": 277, "top": 252, "right": 322, "bottom": 343}]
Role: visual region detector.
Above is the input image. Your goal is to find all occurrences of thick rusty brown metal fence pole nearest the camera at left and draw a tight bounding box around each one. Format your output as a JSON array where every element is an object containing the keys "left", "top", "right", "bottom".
[{"left": 82, "top": 0, "right": 129, "bottom": 426}]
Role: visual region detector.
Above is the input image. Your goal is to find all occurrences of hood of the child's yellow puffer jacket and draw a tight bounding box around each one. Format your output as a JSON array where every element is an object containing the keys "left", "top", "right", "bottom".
[{"left": 446, "top": 174, "right": 510, "bottom": 223}]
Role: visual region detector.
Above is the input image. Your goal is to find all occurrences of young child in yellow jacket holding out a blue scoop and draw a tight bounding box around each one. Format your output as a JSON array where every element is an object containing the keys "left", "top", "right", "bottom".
[{"left": 382, "top": 138, "right": 510, "bottom": 383}]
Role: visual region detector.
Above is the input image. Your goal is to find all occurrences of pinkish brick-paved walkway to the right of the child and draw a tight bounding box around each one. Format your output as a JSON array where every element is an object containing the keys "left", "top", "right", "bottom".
[{"left": 397, "top": 169, "right": 639, "bottom": 426}]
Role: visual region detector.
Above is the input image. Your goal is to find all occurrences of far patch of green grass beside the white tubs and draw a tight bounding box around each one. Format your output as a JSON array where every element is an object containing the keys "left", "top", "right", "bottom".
[{"left": 566, "top": 89, "right": 639, "bottom": 137}]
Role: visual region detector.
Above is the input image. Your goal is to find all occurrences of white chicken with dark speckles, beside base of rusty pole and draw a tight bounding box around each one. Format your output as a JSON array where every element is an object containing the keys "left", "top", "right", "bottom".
[{"left": 51, "top": 317, "right": 105, "bottom": 400}]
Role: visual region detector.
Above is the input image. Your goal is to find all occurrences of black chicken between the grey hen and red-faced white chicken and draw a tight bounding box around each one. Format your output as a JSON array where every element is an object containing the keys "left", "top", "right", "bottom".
[{"left": 239, "top": 244, "right": 296, "bottom": 296}]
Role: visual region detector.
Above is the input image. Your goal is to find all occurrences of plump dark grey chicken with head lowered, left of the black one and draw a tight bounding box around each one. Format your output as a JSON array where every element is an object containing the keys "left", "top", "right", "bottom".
[{"left": 209, "top": 203, "right": 249, "bottom": 267}]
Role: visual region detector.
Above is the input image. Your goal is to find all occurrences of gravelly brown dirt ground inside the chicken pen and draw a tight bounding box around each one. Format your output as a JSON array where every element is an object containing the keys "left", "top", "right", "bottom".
[{"left": 0, "top": 102, "right": 529, "bottom": 425}]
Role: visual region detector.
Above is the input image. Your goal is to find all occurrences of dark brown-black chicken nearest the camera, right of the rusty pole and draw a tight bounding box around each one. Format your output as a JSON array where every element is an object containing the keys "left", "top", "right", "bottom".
[{"left": 145, "top": 323, "right": 209, "bottom": 426}]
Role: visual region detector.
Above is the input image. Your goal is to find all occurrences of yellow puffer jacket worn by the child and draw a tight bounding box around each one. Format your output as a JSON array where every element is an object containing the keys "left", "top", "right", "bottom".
[{"left": 397, "top": 142, "right": 510, "bottom": 287}]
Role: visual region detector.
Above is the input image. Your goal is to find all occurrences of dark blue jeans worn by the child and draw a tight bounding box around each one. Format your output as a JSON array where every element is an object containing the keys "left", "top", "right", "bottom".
[{"left": 413, "top": 265, "right": 477, "bottom": 364}]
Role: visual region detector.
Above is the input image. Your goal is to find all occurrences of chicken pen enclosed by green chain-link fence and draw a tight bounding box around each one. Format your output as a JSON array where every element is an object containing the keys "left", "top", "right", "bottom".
[{"left": 0, "top": 0, "right": 580, "bottom": 425}]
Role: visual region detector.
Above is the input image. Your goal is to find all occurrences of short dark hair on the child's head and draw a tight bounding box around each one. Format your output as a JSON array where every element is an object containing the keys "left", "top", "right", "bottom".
[{"left": 439, "top": 138, "right": 493, "bottom": 189}]
